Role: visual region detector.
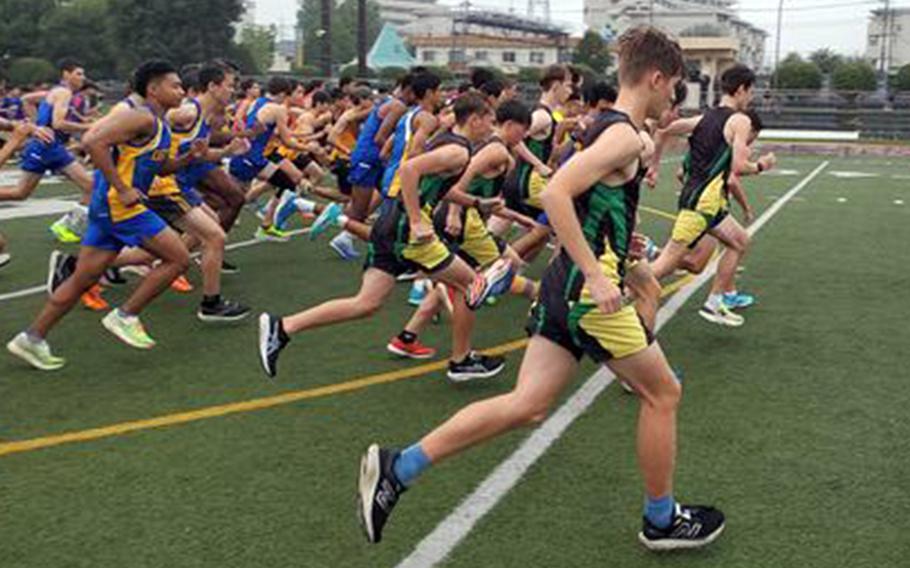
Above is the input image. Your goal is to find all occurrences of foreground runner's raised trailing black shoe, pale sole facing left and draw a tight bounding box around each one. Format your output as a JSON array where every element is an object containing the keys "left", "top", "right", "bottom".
[{"left": 357, "top": 444, "right": 407, "bottom": 544}]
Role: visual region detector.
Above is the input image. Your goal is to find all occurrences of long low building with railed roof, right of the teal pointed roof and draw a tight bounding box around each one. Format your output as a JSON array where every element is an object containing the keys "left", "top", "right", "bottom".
[{"left": 399, "top": 11, "right": 575, "bottom": 73}]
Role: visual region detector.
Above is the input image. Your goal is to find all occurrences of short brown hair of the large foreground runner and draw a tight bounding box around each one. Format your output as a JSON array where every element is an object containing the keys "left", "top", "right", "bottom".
[{"left": 619, "top": 26, "right": 685, "bottom": 83}]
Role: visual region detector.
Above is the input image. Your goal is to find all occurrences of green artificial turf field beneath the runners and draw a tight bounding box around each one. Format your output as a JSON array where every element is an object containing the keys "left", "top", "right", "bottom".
[{"left": 0, "top": 153, "right": 910, "bottom": 568}]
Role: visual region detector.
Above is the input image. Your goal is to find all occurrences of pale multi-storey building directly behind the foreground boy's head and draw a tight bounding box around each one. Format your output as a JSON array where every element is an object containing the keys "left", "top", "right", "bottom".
[{"left": 585, "top": 0, "right": 768, "bottom": 69}]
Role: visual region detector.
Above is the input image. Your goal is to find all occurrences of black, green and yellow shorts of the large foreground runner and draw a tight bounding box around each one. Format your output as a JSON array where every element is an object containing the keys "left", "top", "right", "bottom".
[{"left": 526, "top": 253, "right": 654, "bottom": 363}]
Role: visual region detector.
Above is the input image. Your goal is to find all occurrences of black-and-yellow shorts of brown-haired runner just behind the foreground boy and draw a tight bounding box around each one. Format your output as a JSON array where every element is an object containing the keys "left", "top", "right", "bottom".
[{"left": 364, "top": 207, "right": 455, "bottom": 276}]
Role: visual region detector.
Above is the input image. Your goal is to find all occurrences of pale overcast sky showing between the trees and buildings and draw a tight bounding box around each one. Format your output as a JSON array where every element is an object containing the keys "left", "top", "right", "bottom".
[{"left": 256, "top": 0, "right": 910, "bottom": 58}]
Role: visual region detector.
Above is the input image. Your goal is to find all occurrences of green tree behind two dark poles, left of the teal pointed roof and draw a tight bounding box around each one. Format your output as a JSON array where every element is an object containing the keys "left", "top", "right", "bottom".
[{"left": 297, "top": 0, "right": 382, "bottom": 65}]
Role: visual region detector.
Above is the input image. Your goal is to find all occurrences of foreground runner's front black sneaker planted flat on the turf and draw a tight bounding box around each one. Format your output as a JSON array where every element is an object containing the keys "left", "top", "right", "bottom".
[{"left": 638, "top": 503, "right": 724, "bottom": 551}]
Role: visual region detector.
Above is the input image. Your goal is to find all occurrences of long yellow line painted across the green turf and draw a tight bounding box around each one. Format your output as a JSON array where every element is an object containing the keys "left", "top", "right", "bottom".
[{"left": 0, "top": 276, "right": 692, "bottom": 457}]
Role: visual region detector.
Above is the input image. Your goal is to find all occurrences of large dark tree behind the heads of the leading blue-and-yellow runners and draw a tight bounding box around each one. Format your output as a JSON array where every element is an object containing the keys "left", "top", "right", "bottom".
[{"left": 110, "top": 0, "right": 243, "bottom": 75}]
